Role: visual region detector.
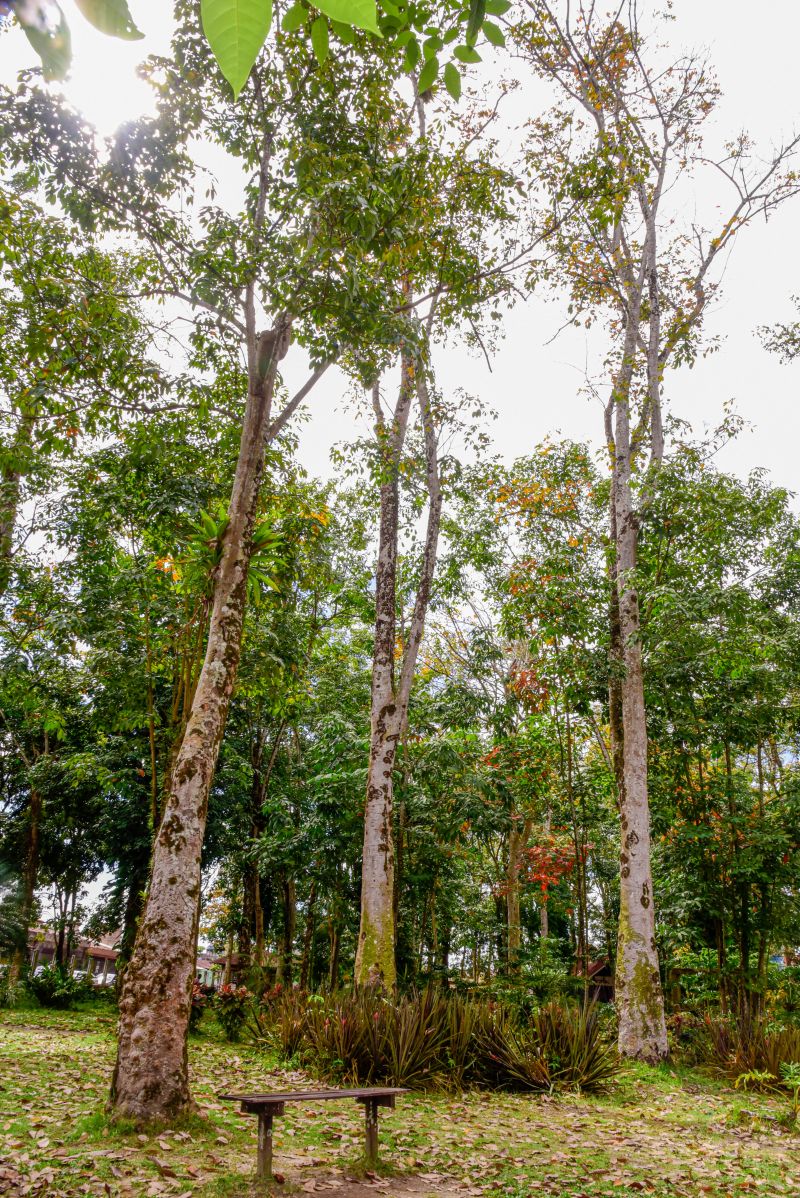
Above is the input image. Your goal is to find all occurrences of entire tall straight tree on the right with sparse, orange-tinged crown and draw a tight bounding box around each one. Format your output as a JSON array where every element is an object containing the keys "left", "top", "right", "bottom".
[{"left": 516, "top": 0, "right": 798, "bottom": 1060}]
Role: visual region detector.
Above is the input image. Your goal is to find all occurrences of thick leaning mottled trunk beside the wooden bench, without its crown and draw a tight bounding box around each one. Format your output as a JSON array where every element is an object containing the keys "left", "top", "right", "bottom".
[{"left": 110, "top": 323, "right": 289, "bottom": 1120}]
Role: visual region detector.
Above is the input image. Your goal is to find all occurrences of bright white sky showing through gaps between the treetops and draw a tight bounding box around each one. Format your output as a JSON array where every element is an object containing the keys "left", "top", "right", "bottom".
[{"left": 0, "top": 0, "right": 800, "bottom": 489}]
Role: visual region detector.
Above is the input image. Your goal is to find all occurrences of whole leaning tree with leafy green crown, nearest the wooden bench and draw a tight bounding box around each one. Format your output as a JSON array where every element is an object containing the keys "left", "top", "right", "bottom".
[{"left": 4, "top": 5, "right": 493, "bottom": 1118}]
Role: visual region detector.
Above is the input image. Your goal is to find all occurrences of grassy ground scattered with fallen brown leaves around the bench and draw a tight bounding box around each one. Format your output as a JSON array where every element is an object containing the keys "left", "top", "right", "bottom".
[{"left": 0, "top": 1009, "right": 800, "bottom": 1198}]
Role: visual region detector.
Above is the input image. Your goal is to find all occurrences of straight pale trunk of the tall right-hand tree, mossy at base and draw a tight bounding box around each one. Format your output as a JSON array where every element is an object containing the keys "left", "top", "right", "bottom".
[{"left": 612, "top": 391, "right": 668, "bottom": 1061}]
